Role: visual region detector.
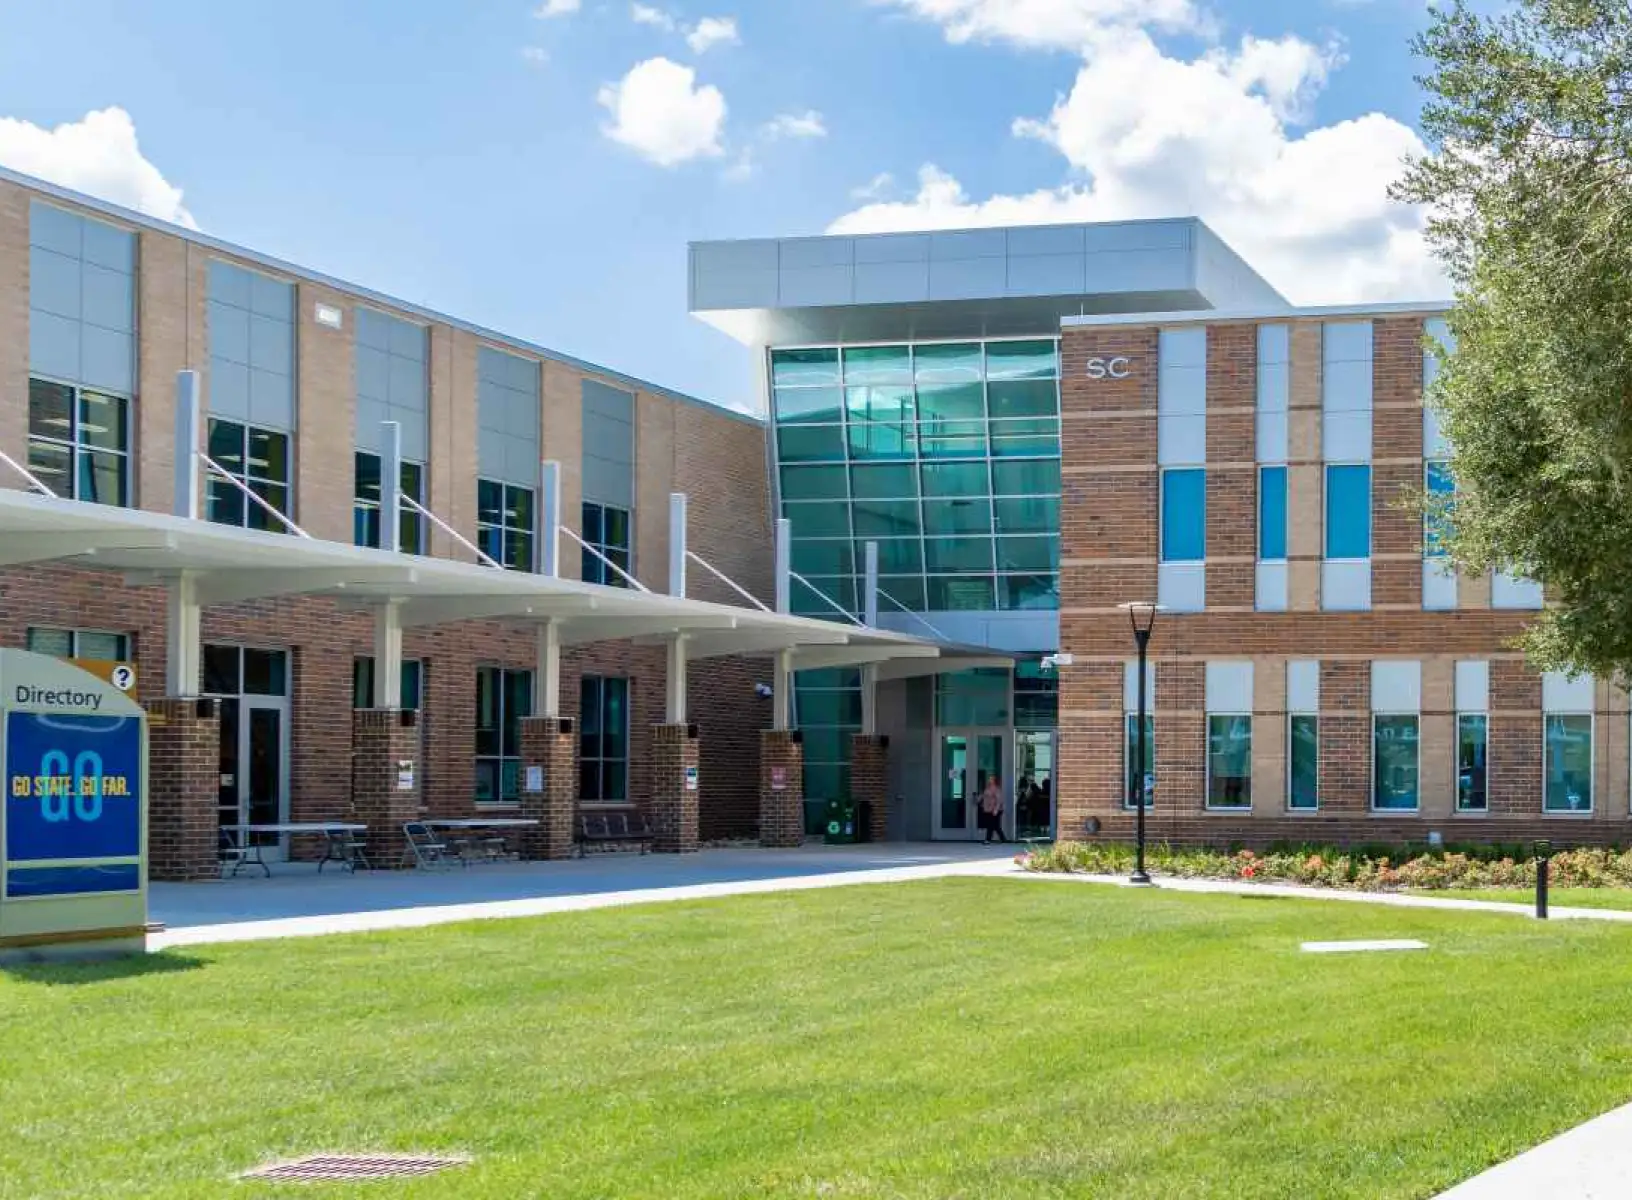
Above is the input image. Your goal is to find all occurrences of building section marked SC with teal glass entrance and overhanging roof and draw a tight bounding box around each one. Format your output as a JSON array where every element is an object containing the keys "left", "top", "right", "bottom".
[{"left": 690, "top": 220, "right": 1629, "bottom": 844}]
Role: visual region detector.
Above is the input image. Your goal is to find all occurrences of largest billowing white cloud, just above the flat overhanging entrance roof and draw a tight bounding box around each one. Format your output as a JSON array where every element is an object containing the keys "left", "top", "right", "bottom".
[{"left": 832, "top": 29, "right": 1446, "bottom": 304}]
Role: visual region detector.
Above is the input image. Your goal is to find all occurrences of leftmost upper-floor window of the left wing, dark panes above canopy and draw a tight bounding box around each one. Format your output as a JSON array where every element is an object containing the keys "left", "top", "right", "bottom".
[{"left": 28, "top": 379, "right": 131, "bottom": 508}]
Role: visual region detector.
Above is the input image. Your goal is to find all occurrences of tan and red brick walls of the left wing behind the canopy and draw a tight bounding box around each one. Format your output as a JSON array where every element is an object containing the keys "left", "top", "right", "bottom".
[{"left": 0, "top": 173, "right": 772, "bottom": 877}]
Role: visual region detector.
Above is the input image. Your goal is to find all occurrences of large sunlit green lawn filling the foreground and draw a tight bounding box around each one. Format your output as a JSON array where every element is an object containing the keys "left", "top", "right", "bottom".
[{"left": 0, "top": 878, "right": 1632, "bottom": 1200}]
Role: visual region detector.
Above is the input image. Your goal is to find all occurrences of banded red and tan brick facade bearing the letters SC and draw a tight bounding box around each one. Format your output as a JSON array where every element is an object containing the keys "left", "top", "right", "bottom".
[{"left": 1056, "top": 312, "right": 1632, "bottom": 844}]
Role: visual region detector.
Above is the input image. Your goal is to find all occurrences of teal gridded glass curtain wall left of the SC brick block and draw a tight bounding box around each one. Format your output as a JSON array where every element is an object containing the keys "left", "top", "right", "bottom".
[{"left": 770, "top": 338, "right": 1059, "bottom": 816}]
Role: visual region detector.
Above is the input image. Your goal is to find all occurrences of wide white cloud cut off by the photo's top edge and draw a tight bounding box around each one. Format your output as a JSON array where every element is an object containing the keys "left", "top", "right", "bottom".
[{"left": 873, "top": 0, "right": 1213, "bottom": 51}]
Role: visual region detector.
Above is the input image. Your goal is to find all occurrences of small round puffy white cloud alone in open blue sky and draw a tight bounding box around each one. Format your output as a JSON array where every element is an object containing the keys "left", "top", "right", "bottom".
[{"left": 597, "top": 59, "right": 726, "bottom": 167}]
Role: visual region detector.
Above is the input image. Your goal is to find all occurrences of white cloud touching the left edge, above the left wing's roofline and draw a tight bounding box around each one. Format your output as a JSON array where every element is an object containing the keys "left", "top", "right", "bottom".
[{"left": 0, "top": 108, "right": 197, "bottom": 229}]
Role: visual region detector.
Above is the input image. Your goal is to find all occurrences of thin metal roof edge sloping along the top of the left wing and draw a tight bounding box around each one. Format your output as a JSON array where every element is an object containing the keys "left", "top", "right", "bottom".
[{"left": 0, "top": 167, "right": 764, "bottom": 424}]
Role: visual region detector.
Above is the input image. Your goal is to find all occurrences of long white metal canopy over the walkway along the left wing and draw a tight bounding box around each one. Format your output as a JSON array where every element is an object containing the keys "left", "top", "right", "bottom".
[{"left": 0, "top": 490, "right": 1012, "bottom": 679}]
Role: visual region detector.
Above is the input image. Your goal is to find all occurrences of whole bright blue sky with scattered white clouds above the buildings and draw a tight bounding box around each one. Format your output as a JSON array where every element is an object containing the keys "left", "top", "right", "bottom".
[{"left": 0, "top": 0, "right": 1443, "bottom": 407}]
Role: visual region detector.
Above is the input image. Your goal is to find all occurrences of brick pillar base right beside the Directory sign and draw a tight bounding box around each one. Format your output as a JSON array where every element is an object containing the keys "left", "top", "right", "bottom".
[{"left": 147, "top": 699, "right": 220, "bottom": 882}]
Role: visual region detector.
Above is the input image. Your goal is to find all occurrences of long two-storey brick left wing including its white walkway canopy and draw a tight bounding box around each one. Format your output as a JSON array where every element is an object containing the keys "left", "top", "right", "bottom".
[{"left": 0, "top": 173, "right": 1000, "bottom": 878}]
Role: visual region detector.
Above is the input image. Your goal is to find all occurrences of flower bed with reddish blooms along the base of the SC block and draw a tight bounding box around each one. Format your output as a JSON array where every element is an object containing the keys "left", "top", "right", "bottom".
[{"left": 1015, "top": 842, "right": 1632, "bottom": 891}]
